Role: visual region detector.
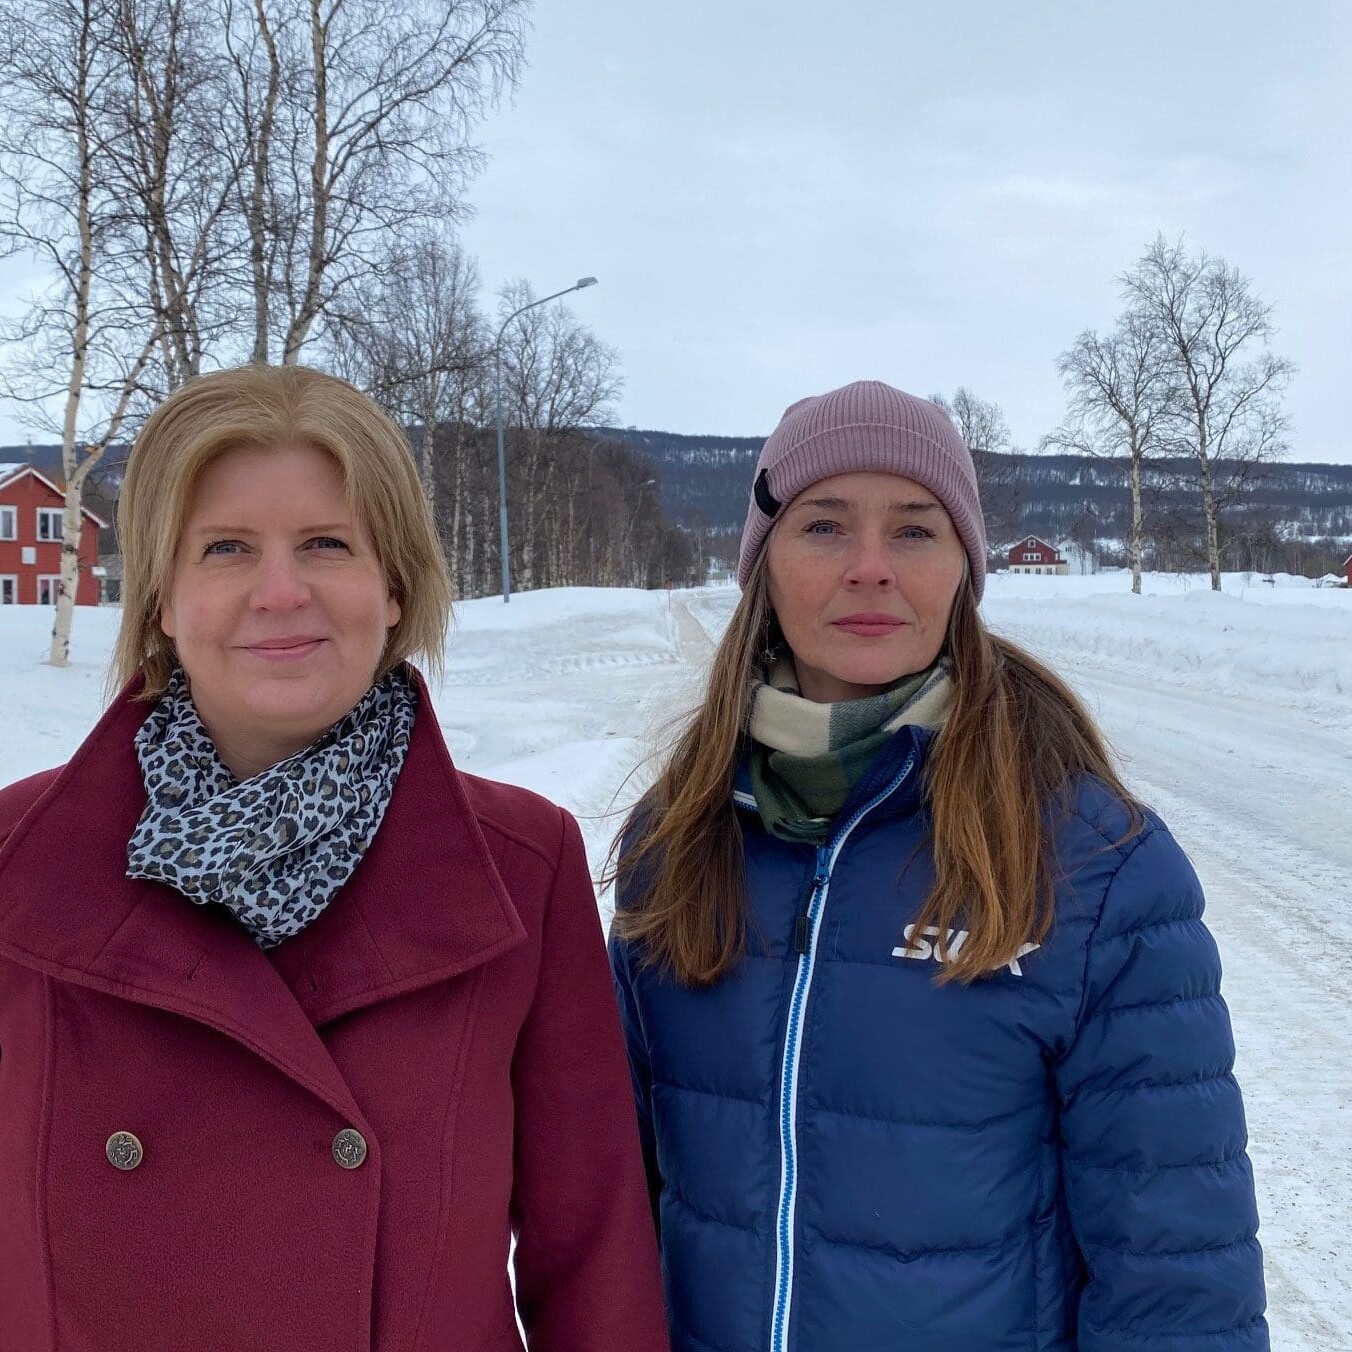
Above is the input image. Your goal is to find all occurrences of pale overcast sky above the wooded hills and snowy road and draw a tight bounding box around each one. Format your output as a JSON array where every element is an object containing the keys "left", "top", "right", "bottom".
[{"left": 0, "top": 0, "right": 1352, "bottom": 461}]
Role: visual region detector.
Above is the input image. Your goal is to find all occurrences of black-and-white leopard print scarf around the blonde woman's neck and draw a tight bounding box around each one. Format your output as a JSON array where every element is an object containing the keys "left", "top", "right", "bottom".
[{"left": 127, "top": 668, "right": 418, "bottom": 949}]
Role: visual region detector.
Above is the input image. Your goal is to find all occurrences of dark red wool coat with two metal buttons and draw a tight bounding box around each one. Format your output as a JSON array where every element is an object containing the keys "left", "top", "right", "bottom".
[{"left": 0, "top": 691, "right": 668, "bottom": 1352}]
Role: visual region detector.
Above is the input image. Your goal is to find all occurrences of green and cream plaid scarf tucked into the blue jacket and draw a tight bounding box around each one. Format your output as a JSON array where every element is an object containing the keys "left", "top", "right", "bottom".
[{"left": 749, "top": 653, "right": 952, "bottom": 845}]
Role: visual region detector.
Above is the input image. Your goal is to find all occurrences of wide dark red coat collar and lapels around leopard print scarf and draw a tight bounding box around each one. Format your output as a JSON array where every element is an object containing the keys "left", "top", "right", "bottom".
[{"left": 0, "top": 677, "right": 526, "bottom": 1114}]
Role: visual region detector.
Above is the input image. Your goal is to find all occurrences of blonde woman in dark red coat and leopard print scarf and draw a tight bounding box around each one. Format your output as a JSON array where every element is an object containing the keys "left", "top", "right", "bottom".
[{"left": 0, "top": 366, "right": 667, "bottom": 1352}]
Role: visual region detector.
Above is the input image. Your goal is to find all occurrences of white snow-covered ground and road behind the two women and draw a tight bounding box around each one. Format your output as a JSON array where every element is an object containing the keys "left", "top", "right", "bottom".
[{"left": 0, "top": 573, "right": 1352, "bottom": 1352}]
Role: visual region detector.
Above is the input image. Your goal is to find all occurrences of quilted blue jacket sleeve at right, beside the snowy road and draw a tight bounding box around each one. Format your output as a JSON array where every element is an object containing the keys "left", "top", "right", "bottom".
[{"left": 1056, "top": 825, "right": 1268, "bottom": 1352}]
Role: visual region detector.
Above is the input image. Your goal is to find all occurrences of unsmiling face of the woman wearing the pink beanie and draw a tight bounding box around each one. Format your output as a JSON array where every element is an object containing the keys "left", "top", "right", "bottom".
[{"left": 767, "top": 473, "right": 967, "bottom": 703}]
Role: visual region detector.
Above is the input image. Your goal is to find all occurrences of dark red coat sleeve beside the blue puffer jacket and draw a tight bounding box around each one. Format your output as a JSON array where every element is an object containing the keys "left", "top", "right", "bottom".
[{"left": 512, "top": 814, "right": 669, "bottom": 1352}]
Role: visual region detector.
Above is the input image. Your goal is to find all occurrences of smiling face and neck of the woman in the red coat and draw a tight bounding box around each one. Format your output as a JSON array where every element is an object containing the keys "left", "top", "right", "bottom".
[{"left": 160, "top": 446, "right": 400, "bottom": 779}]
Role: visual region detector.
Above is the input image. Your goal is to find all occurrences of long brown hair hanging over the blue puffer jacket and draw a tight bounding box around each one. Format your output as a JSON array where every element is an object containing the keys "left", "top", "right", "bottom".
[{"left": 610, "top": 550, "right": 1142, "bottom": 986}]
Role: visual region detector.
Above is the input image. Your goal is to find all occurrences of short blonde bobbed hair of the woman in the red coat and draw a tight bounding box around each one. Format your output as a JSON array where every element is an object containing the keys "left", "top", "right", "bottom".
[{"left": 112, "top": 365, "right": 452, "bottom": 699}]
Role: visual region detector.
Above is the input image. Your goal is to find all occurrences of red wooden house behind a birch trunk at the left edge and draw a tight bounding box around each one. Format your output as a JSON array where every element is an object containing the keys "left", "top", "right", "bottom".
[{"left": 0, "top": 464, "right": 105, "bottom": 606}]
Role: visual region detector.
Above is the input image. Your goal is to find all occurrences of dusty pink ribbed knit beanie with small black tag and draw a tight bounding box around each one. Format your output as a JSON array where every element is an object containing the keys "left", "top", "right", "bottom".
[{"left": 737, "top": 380, "right": 986, "bottom": 600}]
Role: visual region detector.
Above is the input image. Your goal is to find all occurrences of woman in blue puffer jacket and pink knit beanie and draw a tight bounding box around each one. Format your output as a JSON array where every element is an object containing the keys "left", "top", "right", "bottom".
[{"left": 611, "top": 381, "right": 1268, "bottom": 1352}]
